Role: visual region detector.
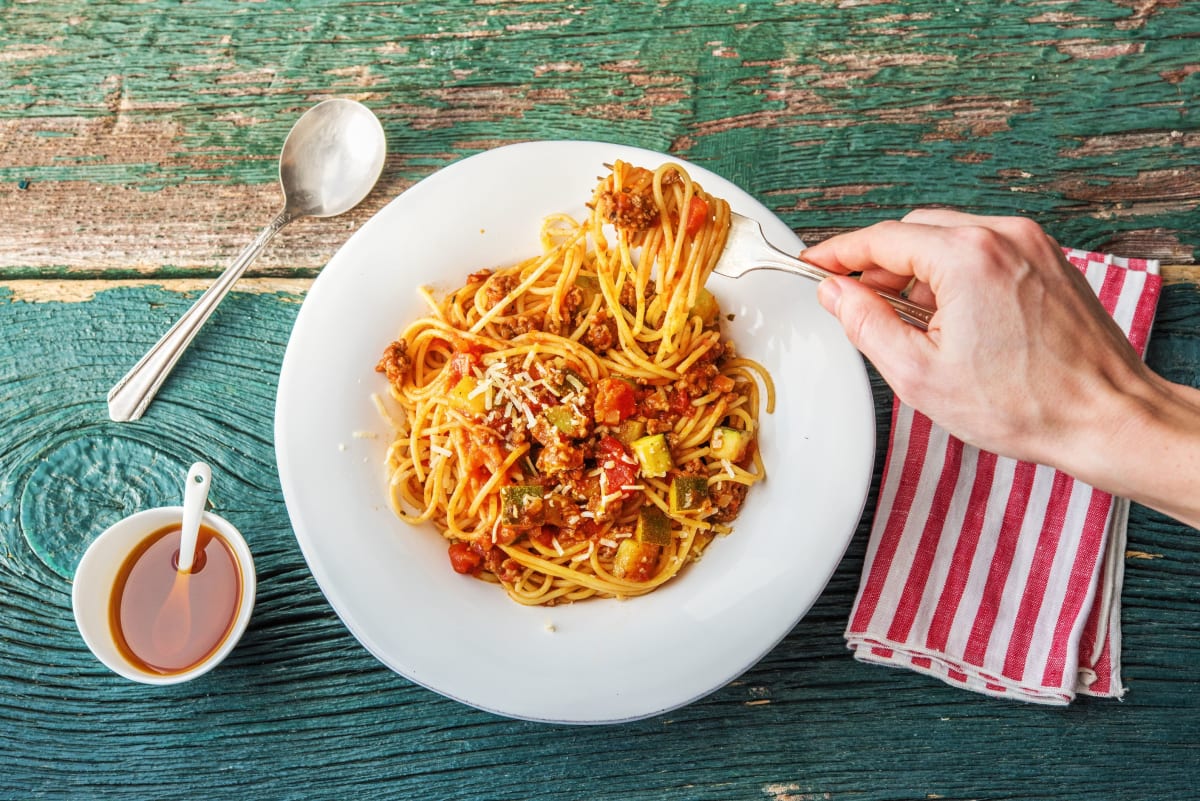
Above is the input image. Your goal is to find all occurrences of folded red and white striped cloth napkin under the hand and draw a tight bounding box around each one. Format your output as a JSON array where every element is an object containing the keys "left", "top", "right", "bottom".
[{"left": 846, "top": 251, "right": 1162, "bottom": 704}]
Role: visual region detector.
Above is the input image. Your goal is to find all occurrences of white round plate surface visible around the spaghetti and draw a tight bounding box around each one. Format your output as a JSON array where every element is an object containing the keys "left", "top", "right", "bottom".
[{"left": 275, "top": 141, "right": 875, "bottom": 723}]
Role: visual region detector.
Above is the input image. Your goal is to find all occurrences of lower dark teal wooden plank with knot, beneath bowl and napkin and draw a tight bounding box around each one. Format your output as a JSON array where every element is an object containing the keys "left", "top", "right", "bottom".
[{"left": 0, "top": 285, "right": 1200, "bottom": 801}]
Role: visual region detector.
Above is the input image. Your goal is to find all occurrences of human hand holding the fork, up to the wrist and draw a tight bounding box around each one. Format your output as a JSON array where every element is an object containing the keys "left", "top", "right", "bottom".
[{"left": 804, "top": 210, "right": 1157, "bottom": 474}]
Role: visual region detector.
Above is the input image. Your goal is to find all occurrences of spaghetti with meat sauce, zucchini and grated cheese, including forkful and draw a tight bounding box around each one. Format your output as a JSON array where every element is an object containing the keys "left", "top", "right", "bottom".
[{"left": 377, "top": 162, "right": 774, "bottom": 604}]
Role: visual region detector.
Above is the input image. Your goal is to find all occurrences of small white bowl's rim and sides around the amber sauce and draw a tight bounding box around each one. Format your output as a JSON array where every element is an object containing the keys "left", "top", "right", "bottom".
[{"left": 71, "top": 506, "right": 257, "bottom": 685}]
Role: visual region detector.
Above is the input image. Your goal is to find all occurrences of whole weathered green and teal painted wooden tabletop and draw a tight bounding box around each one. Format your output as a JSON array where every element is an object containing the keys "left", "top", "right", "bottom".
[{"left": 0, "top": 0, "right": 1200, "bottom": 801}]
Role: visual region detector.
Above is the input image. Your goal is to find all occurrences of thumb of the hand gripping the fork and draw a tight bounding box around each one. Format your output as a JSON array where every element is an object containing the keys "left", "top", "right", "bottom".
[{"left": 817, "top": 276, "right": 931, "bottom": 387}]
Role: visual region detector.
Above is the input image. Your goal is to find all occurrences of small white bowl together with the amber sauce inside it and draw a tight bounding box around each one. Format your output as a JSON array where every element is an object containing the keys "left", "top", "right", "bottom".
[{"left": 71, "top": 506, "right": 256, "bottom": 685}]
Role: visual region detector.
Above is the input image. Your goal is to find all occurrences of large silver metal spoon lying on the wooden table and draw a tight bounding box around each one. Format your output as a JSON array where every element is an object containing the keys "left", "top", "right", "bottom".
[{"left": 108, "top": 98, "right": 388, "bottom": 422}]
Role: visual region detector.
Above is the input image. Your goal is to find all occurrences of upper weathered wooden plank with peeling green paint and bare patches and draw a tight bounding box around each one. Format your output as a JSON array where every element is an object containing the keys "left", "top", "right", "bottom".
[{"left": 0, "top": 0, "right": 1200, "bottom": 277}]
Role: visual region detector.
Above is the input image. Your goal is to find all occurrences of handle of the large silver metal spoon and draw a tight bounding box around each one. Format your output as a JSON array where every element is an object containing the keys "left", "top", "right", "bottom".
[{"left": 108, "top": 209, "right": 299, "bottom": 422}]
